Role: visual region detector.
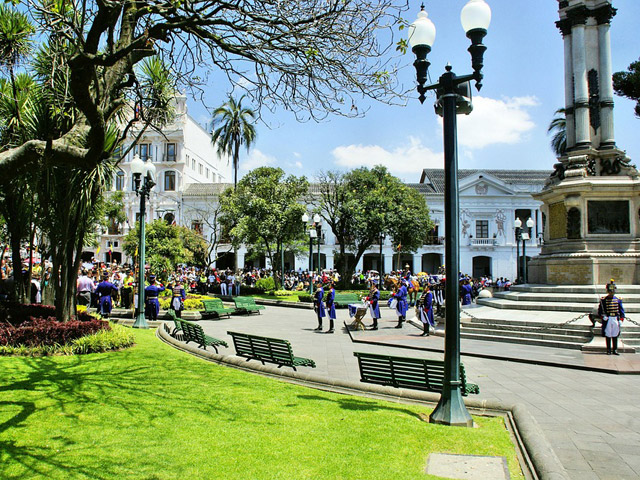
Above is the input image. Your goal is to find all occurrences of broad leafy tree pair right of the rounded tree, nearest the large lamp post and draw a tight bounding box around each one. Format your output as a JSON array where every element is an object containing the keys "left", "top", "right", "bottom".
[{"left": 318, "top": 165, "right": 433, "bottom": 279}]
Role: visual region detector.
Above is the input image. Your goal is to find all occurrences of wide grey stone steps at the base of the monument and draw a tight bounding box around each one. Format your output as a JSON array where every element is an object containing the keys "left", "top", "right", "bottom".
[{"left": 460, "top": 285, "right": 640, "bottom": 353}]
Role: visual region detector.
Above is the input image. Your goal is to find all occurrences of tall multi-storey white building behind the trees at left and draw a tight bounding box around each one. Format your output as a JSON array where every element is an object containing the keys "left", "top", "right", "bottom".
[{"left": 94, "top": 95, "right": 232, "bottom": 263}]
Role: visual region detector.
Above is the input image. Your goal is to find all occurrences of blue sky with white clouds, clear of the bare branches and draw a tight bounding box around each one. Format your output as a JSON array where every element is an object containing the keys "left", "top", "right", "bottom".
[{"left": 184, "top": 0, "right": 640, "bottom": 183}]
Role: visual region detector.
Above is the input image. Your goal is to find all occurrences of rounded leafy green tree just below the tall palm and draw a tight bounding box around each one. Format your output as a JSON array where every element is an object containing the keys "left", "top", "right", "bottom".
[{"left": 220, "top": 167, "right": 309, "bottom": 284}]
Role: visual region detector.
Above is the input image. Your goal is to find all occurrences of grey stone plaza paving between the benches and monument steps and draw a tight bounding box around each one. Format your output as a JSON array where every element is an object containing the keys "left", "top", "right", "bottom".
[{"left": 191, "top": 307, "right": 640, "bottom": 480}]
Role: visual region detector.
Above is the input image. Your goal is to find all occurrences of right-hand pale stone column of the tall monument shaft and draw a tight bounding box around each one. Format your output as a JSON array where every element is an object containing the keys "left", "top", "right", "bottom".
[{"left": 598, "top": 19, "right": 616, "bottom": 148}]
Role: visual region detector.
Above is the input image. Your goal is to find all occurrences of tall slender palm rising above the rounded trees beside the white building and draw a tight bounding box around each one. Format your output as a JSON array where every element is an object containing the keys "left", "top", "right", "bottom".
[{"left": 211, "top": 95, "right": 256, "bottom": 190}]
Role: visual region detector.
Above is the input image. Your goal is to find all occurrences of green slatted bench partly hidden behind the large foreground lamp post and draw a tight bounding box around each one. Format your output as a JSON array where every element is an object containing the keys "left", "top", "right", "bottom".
[{"left": 353, "top": 352, "right": 480, "bottom": 396}]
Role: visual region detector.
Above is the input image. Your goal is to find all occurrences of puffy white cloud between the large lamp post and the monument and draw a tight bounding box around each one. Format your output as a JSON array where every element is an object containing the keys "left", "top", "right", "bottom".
[{"left": 452, "top": 97, "right": 540, "bottom": 149}]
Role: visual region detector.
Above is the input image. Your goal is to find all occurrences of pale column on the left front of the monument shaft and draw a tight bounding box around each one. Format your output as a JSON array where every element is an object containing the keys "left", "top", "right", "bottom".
[{"left": 571, "top": 17, "right": 591, "bottom": 148}]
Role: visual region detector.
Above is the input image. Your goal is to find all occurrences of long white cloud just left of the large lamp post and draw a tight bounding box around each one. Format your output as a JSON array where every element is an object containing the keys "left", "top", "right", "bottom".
[{"left": 331, "top": 138, "right": 443, "bottom": 182}]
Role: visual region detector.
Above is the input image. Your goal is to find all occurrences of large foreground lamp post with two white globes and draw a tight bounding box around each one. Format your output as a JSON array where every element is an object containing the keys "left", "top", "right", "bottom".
[{"left": 409, "top": 0, "right": 491, "bottom": 427}]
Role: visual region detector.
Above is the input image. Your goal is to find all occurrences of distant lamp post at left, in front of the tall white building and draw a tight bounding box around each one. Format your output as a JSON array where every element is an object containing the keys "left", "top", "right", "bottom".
[{"left": 131, "top": 155, "right": 156, "bottom": 328}]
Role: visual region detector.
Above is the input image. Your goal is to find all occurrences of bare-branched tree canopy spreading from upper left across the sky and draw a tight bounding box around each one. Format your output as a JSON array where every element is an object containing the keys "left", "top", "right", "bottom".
[{"left": 0, "top": 0, "right": 406, "bottom": 181}]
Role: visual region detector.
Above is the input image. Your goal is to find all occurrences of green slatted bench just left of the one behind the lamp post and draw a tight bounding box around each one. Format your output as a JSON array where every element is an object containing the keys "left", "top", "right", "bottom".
[{"left": 227, "top": 332, "right": 316, "bottom": 371}]
